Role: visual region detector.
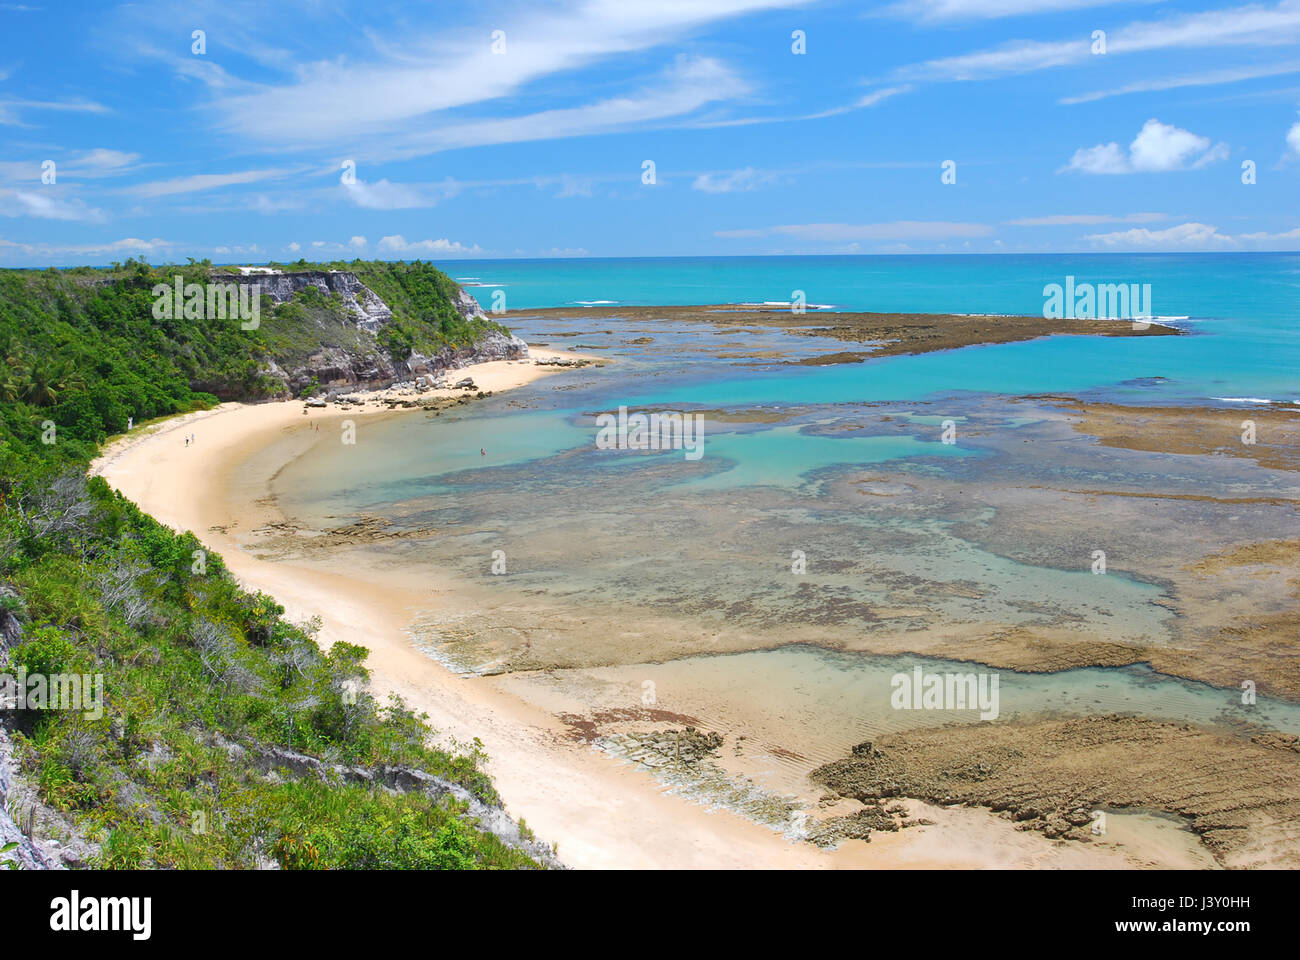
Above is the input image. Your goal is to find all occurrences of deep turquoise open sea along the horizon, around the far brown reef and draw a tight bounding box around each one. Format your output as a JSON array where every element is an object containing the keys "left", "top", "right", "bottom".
[{"left": 460, "top": 254, "right": 1300, "bottom": 403}]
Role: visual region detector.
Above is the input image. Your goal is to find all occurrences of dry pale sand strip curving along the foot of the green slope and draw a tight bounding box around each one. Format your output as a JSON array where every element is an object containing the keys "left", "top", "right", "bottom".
[{"left": 91, "top": 351, "right": 828, "bottom": 868}]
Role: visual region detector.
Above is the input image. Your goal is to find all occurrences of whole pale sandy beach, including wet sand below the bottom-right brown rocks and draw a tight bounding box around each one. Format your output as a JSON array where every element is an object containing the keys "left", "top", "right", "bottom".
[{"left": 92, "top": 349, "right": 1213, "bottom": 869}]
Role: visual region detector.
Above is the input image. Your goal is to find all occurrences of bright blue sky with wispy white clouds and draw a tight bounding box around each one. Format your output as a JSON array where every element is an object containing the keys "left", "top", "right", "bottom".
[{"left": 0, "top": 0, "right": 1300, "bottom": 267}]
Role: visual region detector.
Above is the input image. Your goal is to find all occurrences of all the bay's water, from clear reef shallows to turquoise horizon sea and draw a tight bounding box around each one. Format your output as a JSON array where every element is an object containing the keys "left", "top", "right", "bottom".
[{"left": 261, "top": 255, "right": 1300, "bottom": 790}]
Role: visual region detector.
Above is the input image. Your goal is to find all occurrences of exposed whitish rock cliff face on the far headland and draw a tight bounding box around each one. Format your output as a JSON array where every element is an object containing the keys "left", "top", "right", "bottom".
[{"left": 212, "top": 271, "right": 528, "bottom": 394}]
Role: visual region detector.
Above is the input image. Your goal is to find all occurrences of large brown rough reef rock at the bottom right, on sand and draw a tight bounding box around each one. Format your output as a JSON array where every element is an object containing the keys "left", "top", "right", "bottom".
[{"left": 809, "top": 714, "right": 1300, "bottom": 868}]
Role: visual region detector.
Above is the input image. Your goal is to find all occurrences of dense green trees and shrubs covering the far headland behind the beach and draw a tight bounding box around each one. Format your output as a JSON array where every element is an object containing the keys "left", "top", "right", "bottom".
[{"left": 0, "top": 254, "right": 504, "bottom": 447}]
